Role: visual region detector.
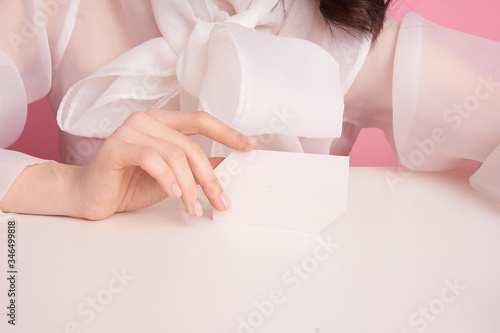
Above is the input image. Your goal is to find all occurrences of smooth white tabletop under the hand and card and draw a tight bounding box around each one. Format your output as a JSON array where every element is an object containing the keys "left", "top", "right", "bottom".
[{"left": 0, "top": 168, "right": 500, "bottom": 333}]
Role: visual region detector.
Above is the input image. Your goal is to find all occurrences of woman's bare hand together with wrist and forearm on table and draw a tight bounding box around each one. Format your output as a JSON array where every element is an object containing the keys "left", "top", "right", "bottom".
[{"left": 0, "top": 109, "right": 256, "bottom": 220}]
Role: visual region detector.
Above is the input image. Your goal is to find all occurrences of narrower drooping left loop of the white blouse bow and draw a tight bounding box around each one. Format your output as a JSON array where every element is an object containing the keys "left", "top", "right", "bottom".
[{"left": 57, "top": 38, "right": 181, "bottom": 138}]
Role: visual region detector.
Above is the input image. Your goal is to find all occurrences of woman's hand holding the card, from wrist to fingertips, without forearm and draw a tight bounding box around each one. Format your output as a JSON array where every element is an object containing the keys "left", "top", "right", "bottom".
[{"left": 75, "top": 109, "right": 256, "bottom": 220}]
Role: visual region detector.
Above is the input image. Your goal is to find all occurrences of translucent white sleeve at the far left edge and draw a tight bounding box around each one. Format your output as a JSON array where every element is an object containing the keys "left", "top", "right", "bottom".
[{"left": 0, "top": 0, "right": 59, "bottom": 208}]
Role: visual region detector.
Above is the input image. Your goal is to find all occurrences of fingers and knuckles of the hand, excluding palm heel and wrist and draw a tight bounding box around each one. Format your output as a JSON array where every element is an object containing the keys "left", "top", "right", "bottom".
[{"left": 107, "top": 110, "right": 245, "bottom": 216}]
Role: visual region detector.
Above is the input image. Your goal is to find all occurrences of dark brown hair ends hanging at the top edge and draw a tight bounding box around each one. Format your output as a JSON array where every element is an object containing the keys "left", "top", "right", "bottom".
[{"left": 315, "top": 0, "right": 392, "bottom": 41}]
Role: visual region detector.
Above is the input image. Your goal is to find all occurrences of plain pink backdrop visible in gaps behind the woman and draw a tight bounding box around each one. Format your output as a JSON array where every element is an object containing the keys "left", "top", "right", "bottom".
[{"left": 10, "top": 0, "right": 500, "bottom": 166}]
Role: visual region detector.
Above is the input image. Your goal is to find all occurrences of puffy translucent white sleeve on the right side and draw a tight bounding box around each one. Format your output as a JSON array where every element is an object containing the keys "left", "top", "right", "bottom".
[{"left": 393, "top": 13, "right": 500, "bottom": 200}]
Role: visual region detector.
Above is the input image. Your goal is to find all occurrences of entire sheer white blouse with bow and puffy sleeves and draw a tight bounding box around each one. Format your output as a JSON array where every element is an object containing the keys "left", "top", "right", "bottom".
[{"left": 0, "top": 0, "right": 500, "bottom": 205}]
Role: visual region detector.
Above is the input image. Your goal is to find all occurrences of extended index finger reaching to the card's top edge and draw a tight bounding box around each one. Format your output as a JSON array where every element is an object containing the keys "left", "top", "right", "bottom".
[{"left": 143, "top": 109, "right": 257, "bottom": 151}]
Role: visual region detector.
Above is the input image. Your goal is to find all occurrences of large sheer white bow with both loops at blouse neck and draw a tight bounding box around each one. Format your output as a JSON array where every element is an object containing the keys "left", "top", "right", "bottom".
[{"left": 57, "top": 1, "right": 344, "bottom": 141}]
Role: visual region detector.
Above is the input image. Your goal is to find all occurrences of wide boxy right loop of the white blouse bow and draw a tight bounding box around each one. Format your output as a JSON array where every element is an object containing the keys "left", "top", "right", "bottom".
[{"left": 200, "top": 23, "right": 344, "bottom": 138}]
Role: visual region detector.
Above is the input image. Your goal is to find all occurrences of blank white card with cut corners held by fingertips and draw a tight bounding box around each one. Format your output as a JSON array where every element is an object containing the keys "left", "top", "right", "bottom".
[{"left": 213, "top": 150, "right": 349, "bottom": 233}]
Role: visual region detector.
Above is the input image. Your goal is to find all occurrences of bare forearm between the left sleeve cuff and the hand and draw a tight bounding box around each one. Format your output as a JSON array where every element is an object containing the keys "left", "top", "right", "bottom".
[{"left": 0, "top": 162, "right": 80, "bottom": 217}]
